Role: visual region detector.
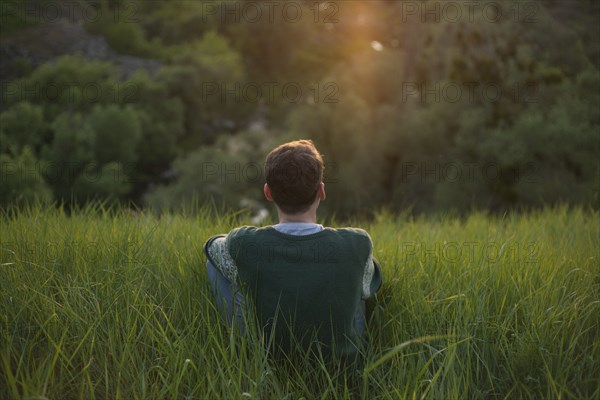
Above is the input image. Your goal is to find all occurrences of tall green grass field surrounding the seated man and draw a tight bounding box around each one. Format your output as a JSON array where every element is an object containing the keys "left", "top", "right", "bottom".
[{"left": 0, "top": 207, "right": 600, "bottom": 400}]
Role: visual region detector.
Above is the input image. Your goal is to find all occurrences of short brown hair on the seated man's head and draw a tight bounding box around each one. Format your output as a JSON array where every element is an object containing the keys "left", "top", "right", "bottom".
[{"left": 265, "top": 140, "right": 325, "bottom": 214}]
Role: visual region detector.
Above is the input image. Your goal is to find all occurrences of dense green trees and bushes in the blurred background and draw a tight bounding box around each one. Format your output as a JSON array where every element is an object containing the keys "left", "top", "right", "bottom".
[{"left": 0, "top": 0, "right": 600, "bottom": 215}]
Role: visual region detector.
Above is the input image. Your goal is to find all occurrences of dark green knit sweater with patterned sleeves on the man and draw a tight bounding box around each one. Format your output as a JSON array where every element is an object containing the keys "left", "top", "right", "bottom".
[{"left": 204, "top": 226, "right": 382, "bottom": 356}]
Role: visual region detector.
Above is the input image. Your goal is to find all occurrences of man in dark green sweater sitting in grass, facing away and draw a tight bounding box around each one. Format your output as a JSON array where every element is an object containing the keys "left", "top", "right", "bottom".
[{"left": 204, "top": 140, "right": 382, "bottom": 359}]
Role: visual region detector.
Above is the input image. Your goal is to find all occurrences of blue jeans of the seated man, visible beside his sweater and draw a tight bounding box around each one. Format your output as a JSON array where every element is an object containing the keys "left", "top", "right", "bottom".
[{"left": 206, "top": 261, "right": 366, "bottom": 336}]
